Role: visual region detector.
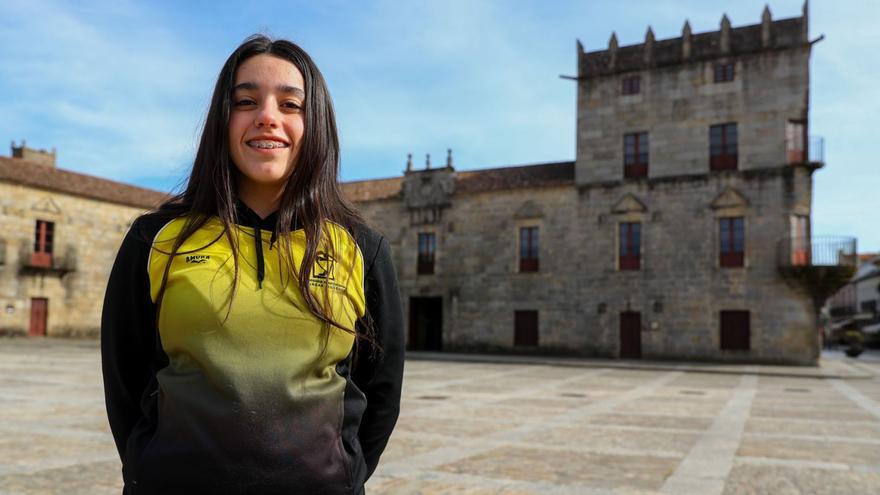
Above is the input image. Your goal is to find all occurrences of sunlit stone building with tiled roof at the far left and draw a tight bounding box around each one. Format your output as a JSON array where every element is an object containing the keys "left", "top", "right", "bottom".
[{"left": 0, "top": 143, "right": 165, "bottom": 336}]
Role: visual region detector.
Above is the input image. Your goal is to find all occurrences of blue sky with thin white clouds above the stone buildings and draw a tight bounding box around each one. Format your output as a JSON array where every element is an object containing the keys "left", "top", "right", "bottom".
[{"left": 0, "top": 0, "right": 880, "bottom": 251}]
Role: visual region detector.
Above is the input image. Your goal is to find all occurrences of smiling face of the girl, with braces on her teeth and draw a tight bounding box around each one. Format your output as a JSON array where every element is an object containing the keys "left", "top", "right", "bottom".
[{"left": 229, "top": 54, "right": 305, "bottom": 199}]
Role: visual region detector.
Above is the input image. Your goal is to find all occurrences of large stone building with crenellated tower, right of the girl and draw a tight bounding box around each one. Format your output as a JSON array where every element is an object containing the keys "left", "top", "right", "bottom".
[{"left": 347, "top": 5, "right": 855, "bottom": 364}]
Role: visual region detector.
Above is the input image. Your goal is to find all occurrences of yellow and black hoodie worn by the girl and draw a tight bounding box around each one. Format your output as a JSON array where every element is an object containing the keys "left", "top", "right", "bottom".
[{"left": 101, "top": 202, "right": 404, "bottom": 495}]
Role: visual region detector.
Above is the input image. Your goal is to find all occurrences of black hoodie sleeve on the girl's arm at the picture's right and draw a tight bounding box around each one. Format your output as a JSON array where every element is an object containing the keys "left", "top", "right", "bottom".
[{"left": 355, "top": 238, "right": 404, "bottom": 478}]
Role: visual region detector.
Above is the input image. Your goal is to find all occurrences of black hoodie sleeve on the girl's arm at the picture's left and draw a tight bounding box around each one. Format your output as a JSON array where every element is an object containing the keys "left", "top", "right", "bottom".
[{"left": 101, "top": 219, "right": 155, "bottom": 458}]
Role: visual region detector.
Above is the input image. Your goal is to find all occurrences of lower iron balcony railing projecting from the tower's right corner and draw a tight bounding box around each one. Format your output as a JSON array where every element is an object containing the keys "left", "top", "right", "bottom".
[{"left": 777, "top": 236, "right": 858, "bottom": 267}]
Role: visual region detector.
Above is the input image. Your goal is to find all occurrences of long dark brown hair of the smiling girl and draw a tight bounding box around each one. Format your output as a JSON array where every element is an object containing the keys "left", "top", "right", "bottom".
[{"left": 156, "top": 35, "right": 378, "bottom": 353}]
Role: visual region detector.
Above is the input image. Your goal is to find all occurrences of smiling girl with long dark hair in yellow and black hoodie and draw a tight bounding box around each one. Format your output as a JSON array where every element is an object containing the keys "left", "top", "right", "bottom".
[{"left": 101, "top": 36, "right": 403, "bottom": 495}]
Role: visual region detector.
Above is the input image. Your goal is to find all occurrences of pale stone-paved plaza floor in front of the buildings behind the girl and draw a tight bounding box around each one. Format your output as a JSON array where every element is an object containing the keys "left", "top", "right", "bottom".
[{"left": 0, "top": 339, "right": 880, "bottom": 495}]
